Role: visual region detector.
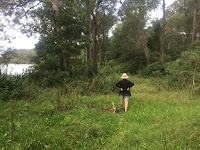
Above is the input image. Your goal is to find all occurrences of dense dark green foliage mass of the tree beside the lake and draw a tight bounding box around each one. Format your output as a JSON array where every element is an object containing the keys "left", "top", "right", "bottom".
[{"left": 32, "top": 2, "right": 88, "bottom": 81}]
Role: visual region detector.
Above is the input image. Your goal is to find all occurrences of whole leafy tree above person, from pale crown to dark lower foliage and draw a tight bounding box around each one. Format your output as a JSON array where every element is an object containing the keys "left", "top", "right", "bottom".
[{"left": 108, "top": 0, "right": 158, "bottom": 72}]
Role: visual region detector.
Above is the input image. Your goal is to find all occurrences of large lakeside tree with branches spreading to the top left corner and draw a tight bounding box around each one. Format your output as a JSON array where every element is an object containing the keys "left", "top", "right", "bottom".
[{"left": 0, "top": 0, "right": 86, "bottom": 77}]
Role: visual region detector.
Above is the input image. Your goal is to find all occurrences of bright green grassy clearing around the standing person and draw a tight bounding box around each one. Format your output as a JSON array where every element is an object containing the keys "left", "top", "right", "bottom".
[{"left": 0, "top": 77, "right": 200, "bottom": 150}]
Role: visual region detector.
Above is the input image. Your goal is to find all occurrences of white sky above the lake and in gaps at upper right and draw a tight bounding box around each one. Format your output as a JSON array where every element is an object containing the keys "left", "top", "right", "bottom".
[{"left": 0, "top": 0, "right": 175, "bottom": 49}]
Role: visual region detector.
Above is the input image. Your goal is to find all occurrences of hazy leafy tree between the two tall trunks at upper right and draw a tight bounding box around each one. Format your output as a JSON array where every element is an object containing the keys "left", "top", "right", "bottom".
[{"left": 166, "top": 0, "right": 199, "bottom": 60}]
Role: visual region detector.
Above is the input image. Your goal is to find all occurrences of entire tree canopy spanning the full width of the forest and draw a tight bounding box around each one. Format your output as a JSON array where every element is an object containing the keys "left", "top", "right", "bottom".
[{"left": 0, "top": 0, "right": 200, "bottom": 85}]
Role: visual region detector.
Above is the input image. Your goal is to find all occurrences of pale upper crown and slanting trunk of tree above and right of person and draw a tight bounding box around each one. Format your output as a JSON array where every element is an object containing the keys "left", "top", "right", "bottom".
[{"left": 115, "top": 0, "right": 159, "bottom": 66}]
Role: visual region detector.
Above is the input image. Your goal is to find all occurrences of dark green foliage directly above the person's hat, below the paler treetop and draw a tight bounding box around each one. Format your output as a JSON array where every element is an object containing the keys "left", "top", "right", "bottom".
[{"left": 110, "top": 26, "right": 146, "bottom": 73}]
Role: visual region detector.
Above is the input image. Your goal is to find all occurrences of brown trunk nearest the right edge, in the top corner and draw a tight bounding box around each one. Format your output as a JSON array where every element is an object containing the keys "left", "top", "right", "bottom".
[{"left": 192, "top": 0, "right": 199, "bottom": 43}]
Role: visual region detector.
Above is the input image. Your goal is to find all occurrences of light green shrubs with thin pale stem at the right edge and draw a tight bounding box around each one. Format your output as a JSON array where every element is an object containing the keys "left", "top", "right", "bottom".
[{"left": 166, "top": 40, "right": 200, "bottom": 88}]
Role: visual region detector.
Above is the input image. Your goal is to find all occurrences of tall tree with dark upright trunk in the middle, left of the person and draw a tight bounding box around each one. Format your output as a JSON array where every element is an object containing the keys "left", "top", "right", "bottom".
[{"left": 83, "top": 0, "right": 117, "bottom": 69}]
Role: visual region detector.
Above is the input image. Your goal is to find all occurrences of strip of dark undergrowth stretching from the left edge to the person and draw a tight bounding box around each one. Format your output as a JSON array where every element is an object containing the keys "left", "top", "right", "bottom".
[{"left": 0, "top": 61, "right": 135, "bottom": 101}]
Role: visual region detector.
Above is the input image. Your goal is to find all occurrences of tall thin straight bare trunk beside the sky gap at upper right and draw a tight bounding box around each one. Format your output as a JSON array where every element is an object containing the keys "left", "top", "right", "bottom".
[{"left": 162, "top": 0, "right": 166, "bottom": 65}]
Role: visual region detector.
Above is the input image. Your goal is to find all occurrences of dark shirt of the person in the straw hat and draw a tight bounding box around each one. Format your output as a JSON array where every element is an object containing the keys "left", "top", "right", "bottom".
[{"left": 116, "top": 79, "right": 134, "bottom": 96}]
